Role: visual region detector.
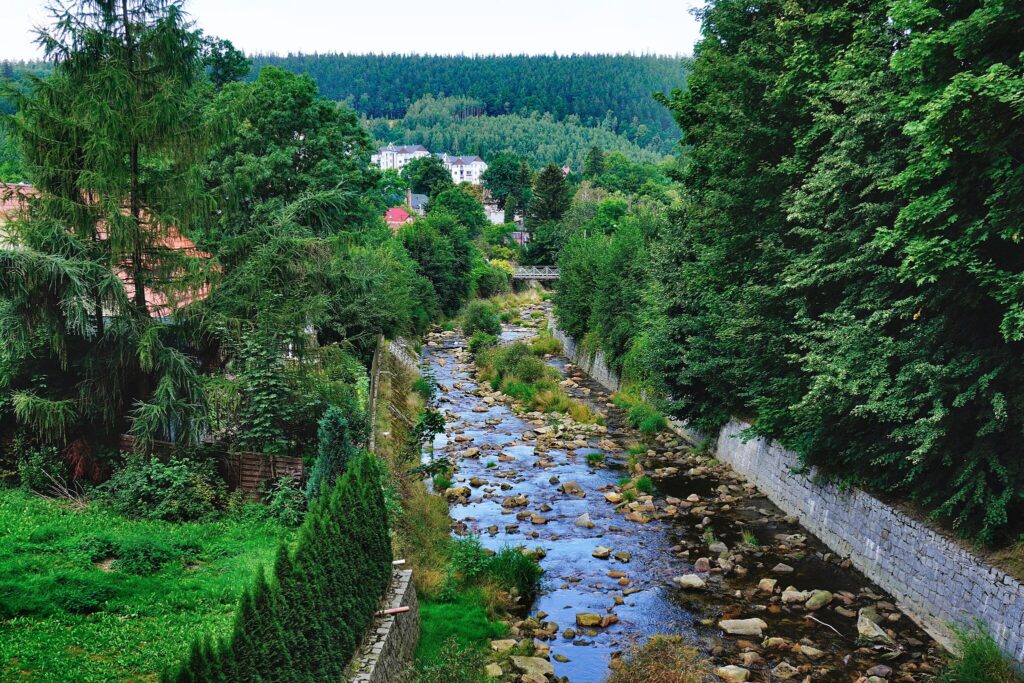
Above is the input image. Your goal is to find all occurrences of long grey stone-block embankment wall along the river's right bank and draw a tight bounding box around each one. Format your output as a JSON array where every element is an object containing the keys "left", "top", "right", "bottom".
[{"left": 552, "top": 319, "right": 1024, "bottom": 665}]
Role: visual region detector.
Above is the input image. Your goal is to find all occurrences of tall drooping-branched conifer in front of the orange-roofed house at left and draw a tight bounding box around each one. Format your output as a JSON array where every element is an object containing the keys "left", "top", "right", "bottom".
[{"left": 0, "top": 0, "right": 206, "bottom": 448}]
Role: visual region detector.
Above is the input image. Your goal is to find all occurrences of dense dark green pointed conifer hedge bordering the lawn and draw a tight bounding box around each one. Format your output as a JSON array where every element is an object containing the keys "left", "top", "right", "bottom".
[{"left": 163, "top": 454, "right": 391, "bottom": 683}]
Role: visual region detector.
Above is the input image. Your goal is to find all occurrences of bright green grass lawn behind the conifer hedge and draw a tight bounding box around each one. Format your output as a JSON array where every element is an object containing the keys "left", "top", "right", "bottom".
[{"left": 0, "top": 488, "right": 288, "bottom": 682}]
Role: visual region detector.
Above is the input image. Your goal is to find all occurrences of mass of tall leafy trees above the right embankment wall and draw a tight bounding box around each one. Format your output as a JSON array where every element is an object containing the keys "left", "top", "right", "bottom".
[{"left": 559, "top": 0, "right": 1024, "bottom": 542}]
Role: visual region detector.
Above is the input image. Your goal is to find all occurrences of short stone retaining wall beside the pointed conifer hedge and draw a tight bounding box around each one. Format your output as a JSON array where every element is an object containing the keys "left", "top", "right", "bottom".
[{"left": 348, "top": 569, "right": 420, "bottom": 683}]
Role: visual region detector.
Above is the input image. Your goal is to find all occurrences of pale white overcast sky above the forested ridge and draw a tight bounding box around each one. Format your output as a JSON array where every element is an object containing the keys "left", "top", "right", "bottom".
[{"left": 0, "top": 0, "right": 702, "bottom": 59}]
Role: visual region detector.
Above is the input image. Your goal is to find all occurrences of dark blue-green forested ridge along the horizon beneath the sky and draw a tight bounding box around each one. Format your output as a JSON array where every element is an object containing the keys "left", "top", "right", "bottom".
[{"left": 250, "top": 54, "right": 689, "bottom": 145}]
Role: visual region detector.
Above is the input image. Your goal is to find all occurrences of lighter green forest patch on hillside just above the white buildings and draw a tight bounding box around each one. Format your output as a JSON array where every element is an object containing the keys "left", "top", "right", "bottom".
[{"left": 366, "top": 95, "right": 662, "bottom": 171}]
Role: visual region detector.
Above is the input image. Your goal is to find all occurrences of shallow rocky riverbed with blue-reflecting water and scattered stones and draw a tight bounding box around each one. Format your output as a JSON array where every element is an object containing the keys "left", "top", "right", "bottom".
[{"left": 423, "top": 304, "right": 941, "bottom": 683}]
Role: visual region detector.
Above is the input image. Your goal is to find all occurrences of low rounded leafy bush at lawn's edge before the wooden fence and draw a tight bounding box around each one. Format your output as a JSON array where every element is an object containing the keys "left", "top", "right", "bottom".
[{"left": 97, "top": 456, "right": 226, "bottom": 522}]
